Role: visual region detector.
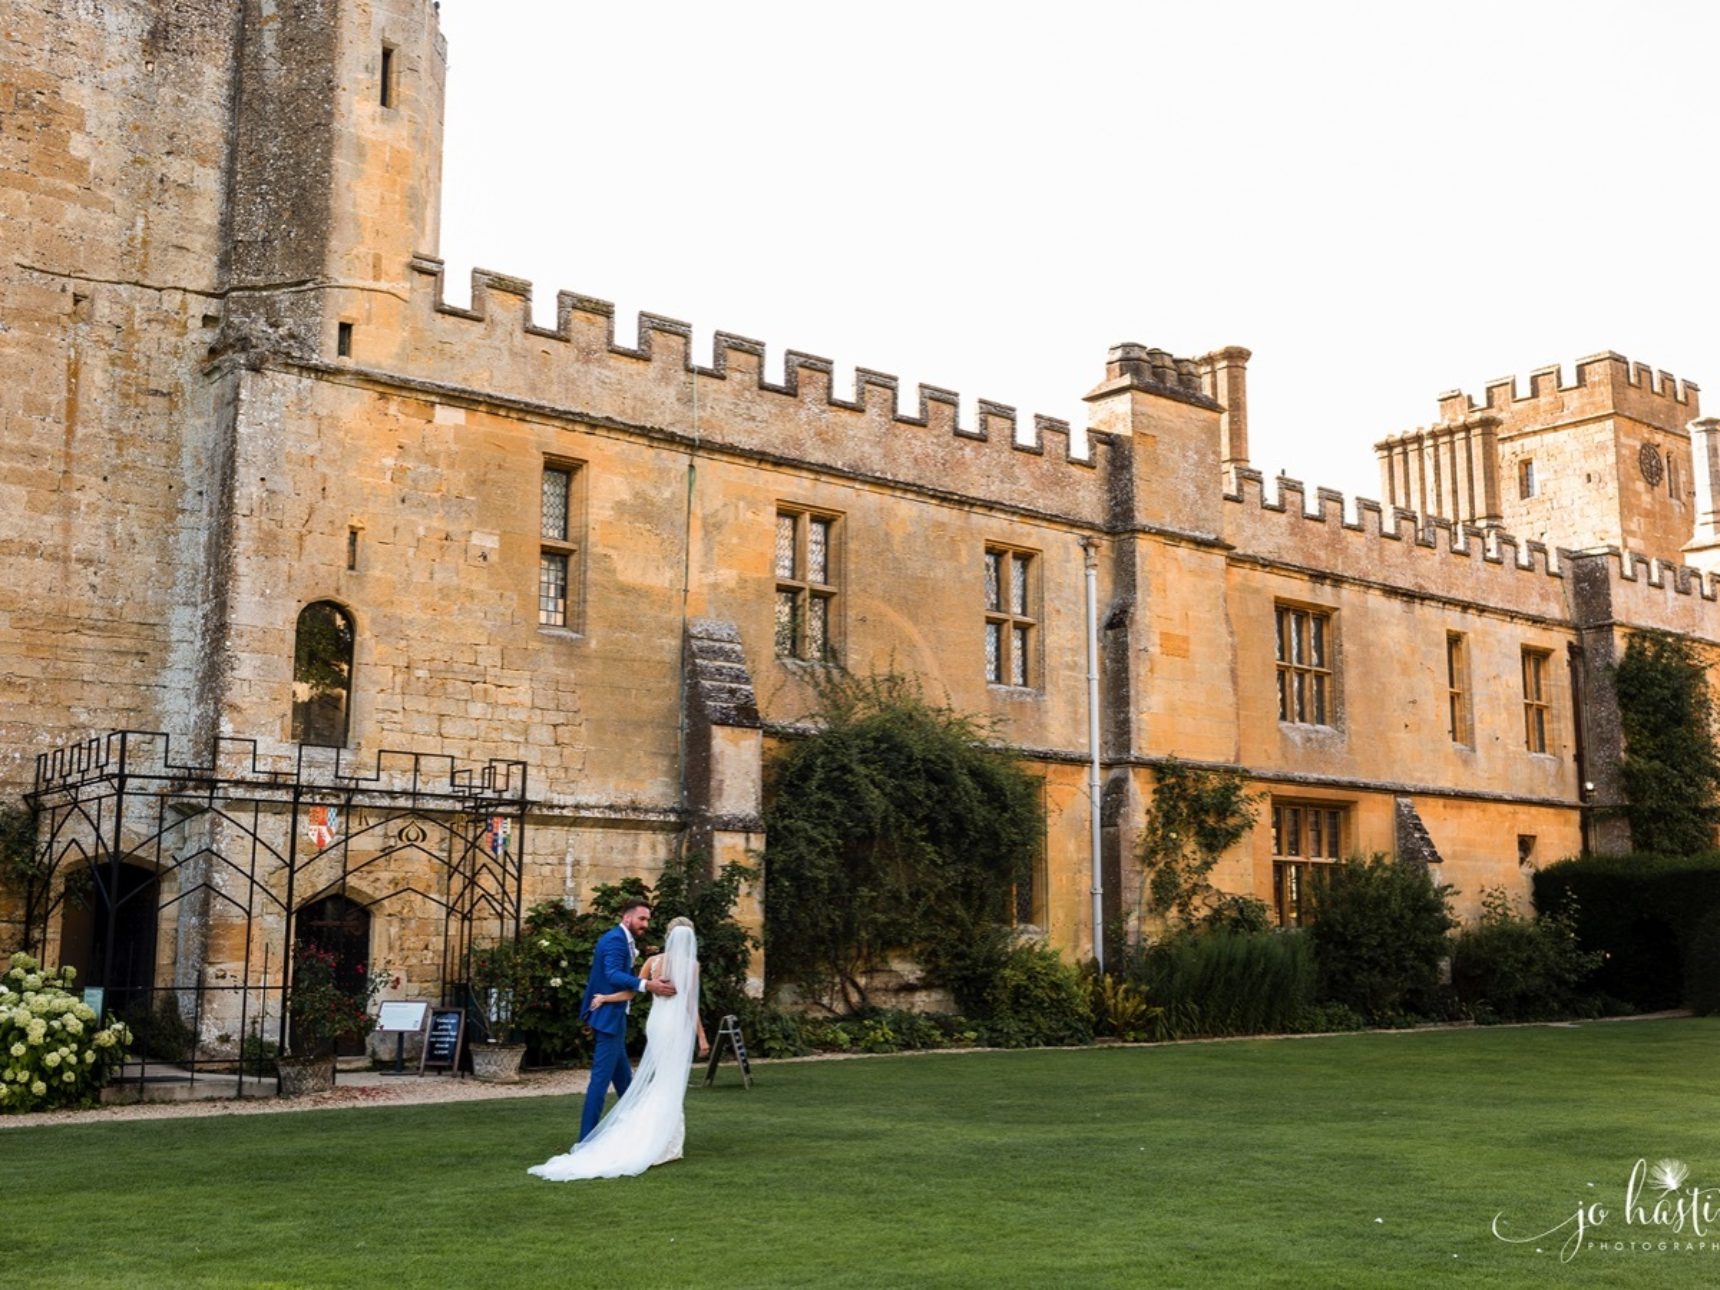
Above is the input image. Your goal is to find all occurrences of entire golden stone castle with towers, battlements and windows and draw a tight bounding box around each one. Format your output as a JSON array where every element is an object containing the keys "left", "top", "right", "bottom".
[{"left": 0, "top": 0, "right": 1720, "bottom": 1047}]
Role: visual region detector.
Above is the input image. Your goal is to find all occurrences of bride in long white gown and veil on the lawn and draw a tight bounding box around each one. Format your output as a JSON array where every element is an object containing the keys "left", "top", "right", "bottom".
[{"left": 526, "top": 918, "right": 709, "bottom": 1182}]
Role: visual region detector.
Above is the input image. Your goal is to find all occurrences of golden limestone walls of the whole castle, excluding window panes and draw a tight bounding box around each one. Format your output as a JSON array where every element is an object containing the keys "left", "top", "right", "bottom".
[{"left": 16, "top": 0, "right": 1720, "bottom": 987}]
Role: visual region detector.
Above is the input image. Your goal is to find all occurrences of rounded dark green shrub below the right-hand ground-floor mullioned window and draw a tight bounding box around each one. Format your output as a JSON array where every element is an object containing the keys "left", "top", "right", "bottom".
[{"left": 1307, "top": 855, "right": 1457, "bottom": 1025}]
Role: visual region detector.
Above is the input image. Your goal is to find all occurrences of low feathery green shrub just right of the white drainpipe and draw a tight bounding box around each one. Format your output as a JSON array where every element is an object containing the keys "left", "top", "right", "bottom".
[{"left": 1130, "top": 931, "right": 1314, "bottom": 1039}]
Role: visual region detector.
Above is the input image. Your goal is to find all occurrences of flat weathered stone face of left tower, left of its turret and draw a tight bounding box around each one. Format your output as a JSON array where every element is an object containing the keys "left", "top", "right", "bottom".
[{"left": 0, "top": 0, "right": 236, "bottom": 795}]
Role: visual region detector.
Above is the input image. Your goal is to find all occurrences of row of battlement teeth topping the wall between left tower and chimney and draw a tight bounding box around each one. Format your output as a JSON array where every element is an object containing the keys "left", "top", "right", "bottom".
[{"left": 411, "top": 255, "right": 1094, "bottom": 468}]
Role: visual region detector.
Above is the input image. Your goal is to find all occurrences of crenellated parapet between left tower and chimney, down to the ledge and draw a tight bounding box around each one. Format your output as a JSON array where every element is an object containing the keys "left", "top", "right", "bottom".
[{"left": 389, "top": 256, "right": 1100, "bottom": 518}]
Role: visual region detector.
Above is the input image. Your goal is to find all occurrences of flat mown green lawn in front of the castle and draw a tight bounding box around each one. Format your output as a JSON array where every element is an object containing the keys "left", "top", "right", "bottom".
[{"left": 0, "top": 1018, "right": 1720, "bottom": 1290}]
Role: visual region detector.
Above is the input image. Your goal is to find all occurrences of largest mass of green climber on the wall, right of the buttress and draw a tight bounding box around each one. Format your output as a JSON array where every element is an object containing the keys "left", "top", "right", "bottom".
[{"left": 764, "top": 676, "right": 1044, "bottom": 1010}]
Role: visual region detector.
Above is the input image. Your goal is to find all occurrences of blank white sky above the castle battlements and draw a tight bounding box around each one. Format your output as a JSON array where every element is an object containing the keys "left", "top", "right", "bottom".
[{"left": 442, "top": 0, "right": 1720, "bottom": 495}]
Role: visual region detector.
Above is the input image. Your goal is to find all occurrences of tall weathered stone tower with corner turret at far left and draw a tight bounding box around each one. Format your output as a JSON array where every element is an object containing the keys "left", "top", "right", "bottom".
[{"left": 0, "top": 0, "right": 445, "bottom": 789}]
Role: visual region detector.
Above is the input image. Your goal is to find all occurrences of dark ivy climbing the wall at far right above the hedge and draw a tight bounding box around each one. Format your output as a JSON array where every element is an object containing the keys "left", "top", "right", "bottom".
[{"left": 1613, "top": 631, "right": 1720, "bottom": 855}]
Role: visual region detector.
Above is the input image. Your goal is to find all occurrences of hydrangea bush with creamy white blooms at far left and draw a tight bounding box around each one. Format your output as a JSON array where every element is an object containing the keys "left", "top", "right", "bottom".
[{"left": 0, "top": 953, "right": 131, "bottom": 1115}]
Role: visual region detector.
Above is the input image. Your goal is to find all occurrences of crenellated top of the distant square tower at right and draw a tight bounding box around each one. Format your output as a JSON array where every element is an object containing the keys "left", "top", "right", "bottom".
[{"left": 1440, "top": 349, "right": 1701, "bottom": 433}]
